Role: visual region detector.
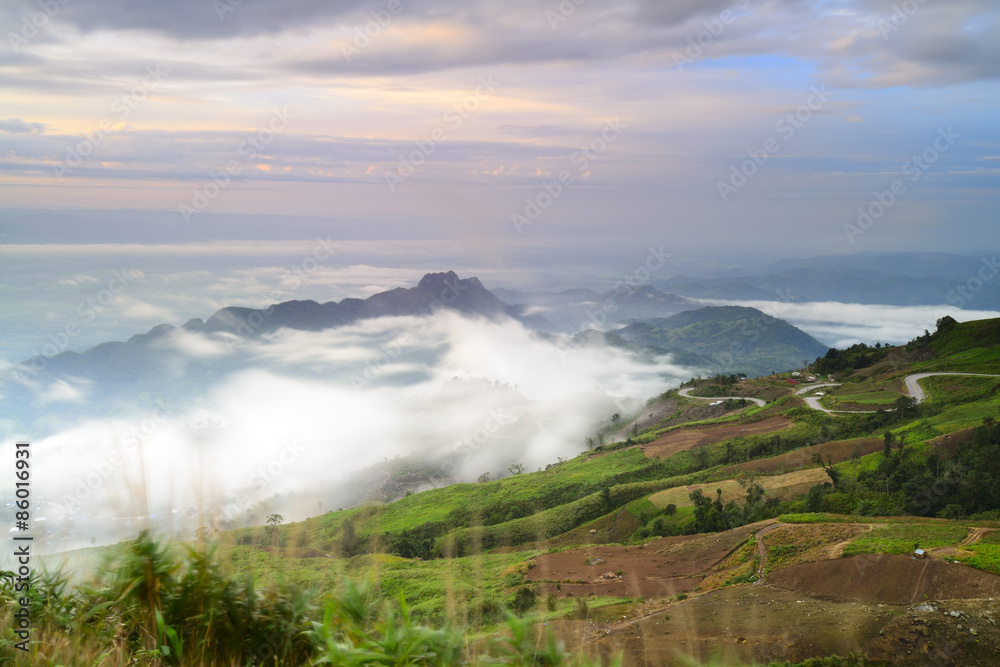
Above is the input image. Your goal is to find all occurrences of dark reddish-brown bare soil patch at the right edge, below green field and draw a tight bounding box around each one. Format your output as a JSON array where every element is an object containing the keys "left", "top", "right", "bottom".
[{"left": 768, "top": 554, "right": 1000, "bottom": 604}]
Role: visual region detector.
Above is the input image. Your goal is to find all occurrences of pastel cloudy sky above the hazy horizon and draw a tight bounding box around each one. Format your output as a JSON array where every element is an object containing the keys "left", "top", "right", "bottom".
[{"left": 0, "top": 0, "right": 1000, "bottom": 255}]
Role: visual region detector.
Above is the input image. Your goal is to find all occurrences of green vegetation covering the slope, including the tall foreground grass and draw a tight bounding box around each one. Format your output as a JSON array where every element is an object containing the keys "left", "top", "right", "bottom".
[{"left": 7, "top": 319, "right": 1000, "bottom": 667}]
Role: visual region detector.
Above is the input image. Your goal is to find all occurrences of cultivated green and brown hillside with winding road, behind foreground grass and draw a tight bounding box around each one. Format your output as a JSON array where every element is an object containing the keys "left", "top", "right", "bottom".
[{"left": 13, "top": 319, "right": 1000, "bottom": 665}]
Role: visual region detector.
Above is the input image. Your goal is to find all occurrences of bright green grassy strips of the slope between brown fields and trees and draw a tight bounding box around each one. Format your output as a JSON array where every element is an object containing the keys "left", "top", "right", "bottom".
[{"left": 197, "top": 323, "right": 1000, "bottom": 636}]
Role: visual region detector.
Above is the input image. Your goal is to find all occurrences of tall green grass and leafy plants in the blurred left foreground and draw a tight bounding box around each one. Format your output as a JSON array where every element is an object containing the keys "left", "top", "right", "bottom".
[{"left": 0, "top": 532, "right": 620, "bottom": 667}]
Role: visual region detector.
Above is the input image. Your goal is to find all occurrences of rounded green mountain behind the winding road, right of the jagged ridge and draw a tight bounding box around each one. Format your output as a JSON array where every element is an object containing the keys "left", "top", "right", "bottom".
[{"left": 614, "top": 306, "right": 828, "bottom": 376}]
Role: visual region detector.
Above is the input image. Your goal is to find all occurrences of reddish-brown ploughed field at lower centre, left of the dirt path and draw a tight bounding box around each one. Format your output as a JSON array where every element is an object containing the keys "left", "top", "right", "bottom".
[{"left": 525, "top": 524, "right": 760, "bottom": 597}]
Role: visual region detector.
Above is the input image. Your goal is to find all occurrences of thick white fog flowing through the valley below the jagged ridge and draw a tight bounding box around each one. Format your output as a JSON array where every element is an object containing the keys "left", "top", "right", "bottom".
[{"left": 9, "top": 312, "right": 698, "bottom": 551}]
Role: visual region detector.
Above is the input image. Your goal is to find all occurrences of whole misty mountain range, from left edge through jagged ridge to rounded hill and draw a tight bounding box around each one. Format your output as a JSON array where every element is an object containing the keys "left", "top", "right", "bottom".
[{"left": 0, "top": 271, "right": 827, "bottom": 432}]
